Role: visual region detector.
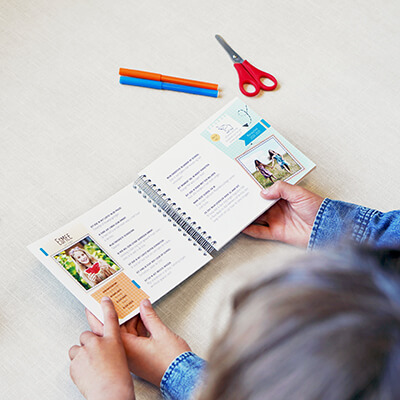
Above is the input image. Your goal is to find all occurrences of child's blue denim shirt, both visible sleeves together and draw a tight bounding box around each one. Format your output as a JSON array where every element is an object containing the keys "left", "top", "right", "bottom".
[{"left": 160, "top": 199, "right": 400, "bottom": 400}]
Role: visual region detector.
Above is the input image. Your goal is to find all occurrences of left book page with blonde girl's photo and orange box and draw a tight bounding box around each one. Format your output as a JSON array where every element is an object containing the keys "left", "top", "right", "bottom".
[{"left": 29, "top": 185, "right": 211, "bottom": 323}]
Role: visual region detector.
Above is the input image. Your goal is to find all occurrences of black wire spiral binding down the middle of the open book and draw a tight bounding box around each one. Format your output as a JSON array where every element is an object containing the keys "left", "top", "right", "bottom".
[{"left": 133, "top": 175, "right": 217, "bottom": 255}]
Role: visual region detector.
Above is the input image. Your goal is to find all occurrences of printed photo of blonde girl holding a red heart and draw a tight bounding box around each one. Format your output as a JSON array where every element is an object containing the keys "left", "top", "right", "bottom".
[{"left": 54, "top": 236, "right": 119, "bottom": 290}]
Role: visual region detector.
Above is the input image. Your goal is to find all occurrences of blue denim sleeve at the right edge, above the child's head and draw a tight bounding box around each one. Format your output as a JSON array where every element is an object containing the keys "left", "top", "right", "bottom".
[{"left": 308, "top": 199, "right": 400, "bottom": 250}]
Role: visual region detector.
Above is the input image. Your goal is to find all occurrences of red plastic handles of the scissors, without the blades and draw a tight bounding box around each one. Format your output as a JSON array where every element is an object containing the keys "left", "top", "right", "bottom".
[{"left": 234, "top": 60, "right": 278, "bottom": 97}]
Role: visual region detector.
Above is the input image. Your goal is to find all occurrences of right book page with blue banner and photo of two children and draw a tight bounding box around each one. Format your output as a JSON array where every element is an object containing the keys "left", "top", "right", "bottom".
[{"left": 141, "top": 99, "right": 315, "bottom": 250}]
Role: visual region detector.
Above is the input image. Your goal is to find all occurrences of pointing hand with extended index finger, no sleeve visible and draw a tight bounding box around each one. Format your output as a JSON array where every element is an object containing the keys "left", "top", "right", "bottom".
[{"left": 69, "top": 299, "right": 135, "bottom": 400}]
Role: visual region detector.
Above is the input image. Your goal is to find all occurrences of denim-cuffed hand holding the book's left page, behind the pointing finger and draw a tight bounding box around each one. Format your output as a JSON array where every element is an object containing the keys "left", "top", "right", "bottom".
[{"left": 86, "top": 300, "right": 190, "bottom": 386}]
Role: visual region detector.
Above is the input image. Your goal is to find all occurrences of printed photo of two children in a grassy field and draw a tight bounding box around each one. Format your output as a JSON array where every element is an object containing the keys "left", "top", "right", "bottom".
[{"left": 236, "top": 136, "right": 303, "bottom": 188}]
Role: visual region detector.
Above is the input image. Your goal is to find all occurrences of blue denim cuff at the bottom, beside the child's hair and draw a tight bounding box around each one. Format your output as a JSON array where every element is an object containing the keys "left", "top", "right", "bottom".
[{"left": 160, "top": 351, "right": 207, "bottom": 400}]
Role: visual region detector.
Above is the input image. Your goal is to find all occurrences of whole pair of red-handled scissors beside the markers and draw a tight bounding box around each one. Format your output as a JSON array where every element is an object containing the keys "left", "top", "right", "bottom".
[{"left": 215, "top": 35, "right": 278, "bottom": 97}]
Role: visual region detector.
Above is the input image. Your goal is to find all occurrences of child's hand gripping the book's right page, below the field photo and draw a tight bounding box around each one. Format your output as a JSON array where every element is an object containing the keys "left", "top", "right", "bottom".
[{"left": 243, "top": 181, "right": 323, "bottom": 247}]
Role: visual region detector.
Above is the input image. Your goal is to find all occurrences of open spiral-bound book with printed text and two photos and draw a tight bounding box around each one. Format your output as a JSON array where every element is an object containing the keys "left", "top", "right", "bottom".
[{"left": 29, "top": 99, "right": 315, "bottom": 323}]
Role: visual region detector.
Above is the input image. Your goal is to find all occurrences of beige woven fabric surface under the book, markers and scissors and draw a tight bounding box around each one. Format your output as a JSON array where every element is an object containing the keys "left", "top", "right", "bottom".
[{"left": 0, "top": 0, "right": 400, "bottom": 400}]
